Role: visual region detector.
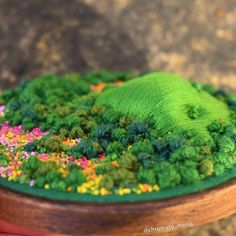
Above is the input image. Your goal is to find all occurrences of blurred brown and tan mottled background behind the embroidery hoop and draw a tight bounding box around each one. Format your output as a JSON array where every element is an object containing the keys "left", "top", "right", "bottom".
[{"left": 0, "top": 0, "right": 236, "bottom": 236}]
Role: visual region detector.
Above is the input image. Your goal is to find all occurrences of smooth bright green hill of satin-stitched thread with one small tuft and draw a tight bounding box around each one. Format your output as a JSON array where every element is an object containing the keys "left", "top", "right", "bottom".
[{"left": 97, "top": 72, "right": 230, "bottom": 133}]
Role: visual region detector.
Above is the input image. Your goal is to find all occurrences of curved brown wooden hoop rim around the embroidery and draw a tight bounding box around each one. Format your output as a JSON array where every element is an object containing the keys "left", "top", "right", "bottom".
[{"left": 0, "top": 181, "right": 236, "bottom": 235}]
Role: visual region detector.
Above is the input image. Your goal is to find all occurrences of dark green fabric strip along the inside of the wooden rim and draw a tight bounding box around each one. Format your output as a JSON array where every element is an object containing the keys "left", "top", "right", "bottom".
[{"left": 0, "top": 166, "right": 236, "bottom": 203}]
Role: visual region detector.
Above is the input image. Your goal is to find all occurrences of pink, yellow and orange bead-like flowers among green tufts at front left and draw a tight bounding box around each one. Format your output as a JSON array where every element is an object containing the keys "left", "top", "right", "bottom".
[{"left": 0, "top": 118, "right": 159, "bottom": 196}]
